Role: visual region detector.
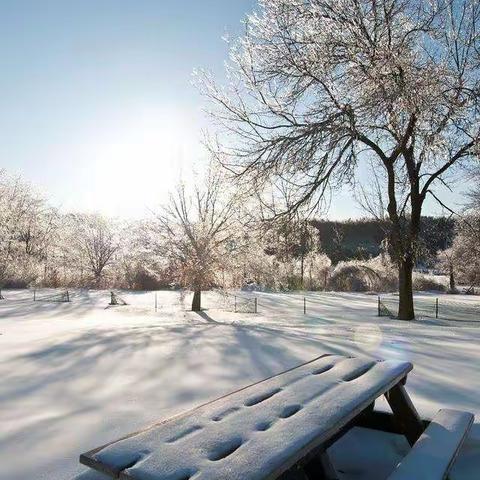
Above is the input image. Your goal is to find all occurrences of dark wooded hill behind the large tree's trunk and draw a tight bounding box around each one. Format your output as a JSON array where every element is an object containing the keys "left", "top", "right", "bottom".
[{"left": 312, "top": 217, "right": 455, "bottom": 266}]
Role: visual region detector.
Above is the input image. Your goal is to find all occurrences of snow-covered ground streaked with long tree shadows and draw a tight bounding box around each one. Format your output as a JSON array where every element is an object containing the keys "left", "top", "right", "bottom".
[{"left": 0, "top": 290, "right": 480, "bottom": 480}]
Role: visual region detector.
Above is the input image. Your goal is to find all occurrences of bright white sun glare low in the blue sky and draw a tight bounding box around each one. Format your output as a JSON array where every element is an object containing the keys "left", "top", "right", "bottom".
[{"left": 85, "top": 109, "right": 201, "bottom": 216}]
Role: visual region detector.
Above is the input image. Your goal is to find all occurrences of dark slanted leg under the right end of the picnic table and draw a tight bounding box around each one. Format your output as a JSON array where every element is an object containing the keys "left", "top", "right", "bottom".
[{"left": 385, "top": 383, "right": 425, "bottom": 445}]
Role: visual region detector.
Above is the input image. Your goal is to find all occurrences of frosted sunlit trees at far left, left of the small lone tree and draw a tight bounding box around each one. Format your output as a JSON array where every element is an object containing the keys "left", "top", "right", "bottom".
[{"left": 0, "top": 171, "right": 163, "bottom": 288}]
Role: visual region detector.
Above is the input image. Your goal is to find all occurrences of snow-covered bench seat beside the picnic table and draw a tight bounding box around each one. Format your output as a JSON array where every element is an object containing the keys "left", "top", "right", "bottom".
[{"left": 388, "top": 410, "right": 474, "bottom": 480}]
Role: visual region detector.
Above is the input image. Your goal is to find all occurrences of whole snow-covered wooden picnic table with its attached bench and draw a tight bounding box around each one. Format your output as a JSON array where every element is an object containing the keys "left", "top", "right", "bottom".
[{"left": 80, "top": 354, "right": 473, "bottom": 480}]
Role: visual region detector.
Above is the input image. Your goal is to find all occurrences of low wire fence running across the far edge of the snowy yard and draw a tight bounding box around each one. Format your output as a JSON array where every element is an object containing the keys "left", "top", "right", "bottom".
[{"left": 0, "top": 288, "right": 480, "bottom": 327}]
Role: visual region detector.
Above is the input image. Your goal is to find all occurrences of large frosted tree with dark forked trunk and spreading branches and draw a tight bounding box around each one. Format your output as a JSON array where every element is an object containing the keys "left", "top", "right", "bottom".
[{"left": 202, "top": 0, "right": 480, "bottom": 319}]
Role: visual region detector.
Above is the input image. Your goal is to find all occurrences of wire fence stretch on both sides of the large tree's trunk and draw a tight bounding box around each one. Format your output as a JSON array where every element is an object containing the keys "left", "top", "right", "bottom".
[{"left": 377, "top": 295, "right": 480, "bottom": 324}]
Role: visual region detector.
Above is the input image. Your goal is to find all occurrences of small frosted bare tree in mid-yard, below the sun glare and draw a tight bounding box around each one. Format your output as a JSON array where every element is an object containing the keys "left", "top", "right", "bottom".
[{"left": 156, "top": 168, "right": 239, "bottom": 311}]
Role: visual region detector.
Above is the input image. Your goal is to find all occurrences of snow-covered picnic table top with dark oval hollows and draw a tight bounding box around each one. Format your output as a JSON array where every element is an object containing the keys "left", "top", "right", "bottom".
[{"left": 82, "top": 355, "right": 412, "bottom": 480}]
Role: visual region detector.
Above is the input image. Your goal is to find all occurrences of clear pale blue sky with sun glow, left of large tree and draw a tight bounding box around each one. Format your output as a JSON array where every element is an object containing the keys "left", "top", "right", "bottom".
[{"left": 0, "top": 0, "right": 468, "bottom": 218}]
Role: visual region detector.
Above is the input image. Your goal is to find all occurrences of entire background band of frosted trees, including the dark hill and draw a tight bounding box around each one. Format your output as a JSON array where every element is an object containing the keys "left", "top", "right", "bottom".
[{"left": 0, "top": 172, "right": 480, "bottom": 291}]
